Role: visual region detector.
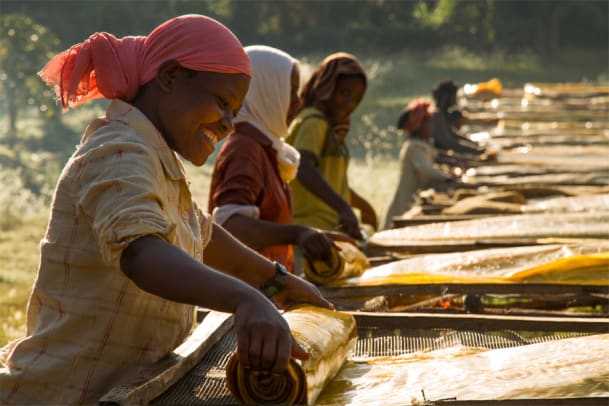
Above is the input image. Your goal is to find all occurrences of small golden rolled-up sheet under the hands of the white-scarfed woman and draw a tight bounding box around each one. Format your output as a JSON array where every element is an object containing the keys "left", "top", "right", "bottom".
[{"left": 304, "top": 241, "right": 370, "bottom": 285}]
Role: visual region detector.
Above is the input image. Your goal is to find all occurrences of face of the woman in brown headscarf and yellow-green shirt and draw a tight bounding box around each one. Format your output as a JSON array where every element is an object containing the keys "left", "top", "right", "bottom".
[{"left": 324, "top": 75, "right": 366, "bottom": 123}]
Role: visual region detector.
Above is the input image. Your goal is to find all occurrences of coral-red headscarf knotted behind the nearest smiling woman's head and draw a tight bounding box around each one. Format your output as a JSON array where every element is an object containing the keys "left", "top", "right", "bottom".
[{"left": 38, "top": 14, "right": 251, "bottom": 108}]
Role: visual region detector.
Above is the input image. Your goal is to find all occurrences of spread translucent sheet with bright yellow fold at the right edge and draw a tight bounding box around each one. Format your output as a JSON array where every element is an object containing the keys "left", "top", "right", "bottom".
[{"left": 341, "top": 244, "right": 609, "bottom": 286}]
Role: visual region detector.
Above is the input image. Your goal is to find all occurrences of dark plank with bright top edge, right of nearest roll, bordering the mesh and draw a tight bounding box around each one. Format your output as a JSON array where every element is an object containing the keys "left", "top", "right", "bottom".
[{"left": 348, "top": 312, "right": 609, "bottom": 333}]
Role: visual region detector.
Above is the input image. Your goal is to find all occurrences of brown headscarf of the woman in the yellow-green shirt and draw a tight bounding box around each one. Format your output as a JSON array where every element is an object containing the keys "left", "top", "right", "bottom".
[{"left": 300, "top": 52, "right": 366, "bottom": 107}]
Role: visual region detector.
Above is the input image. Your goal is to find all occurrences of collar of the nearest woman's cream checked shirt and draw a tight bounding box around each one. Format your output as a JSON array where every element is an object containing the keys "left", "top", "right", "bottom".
[{"left": 106, "top": 99, "right": 186, "bottom": 180}]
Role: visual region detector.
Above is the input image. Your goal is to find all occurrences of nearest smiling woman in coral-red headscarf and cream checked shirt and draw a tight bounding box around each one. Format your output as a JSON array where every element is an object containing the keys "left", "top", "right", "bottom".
[{"left": 0, "top": 15, "right": 331, "bottom": 404}]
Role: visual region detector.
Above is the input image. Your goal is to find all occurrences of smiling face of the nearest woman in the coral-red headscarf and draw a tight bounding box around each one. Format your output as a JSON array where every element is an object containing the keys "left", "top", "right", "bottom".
[{"left": 155, "top": 65, "right": 250, "bottom": 166}]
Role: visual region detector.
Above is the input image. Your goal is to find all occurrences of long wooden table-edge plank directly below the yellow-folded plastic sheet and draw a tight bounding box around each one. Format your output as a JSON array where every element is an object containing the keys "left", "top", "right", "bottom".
[{"left": 318, "top": 283, "right": 609, "bottom": 300}]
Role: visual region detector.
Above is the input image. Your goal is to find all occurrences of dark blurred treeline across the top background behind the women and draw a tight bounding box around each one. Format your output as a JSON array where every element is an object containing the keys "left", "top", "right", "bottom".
[{"left": 3, "top": 0, "right": 609, "bottom": 56}]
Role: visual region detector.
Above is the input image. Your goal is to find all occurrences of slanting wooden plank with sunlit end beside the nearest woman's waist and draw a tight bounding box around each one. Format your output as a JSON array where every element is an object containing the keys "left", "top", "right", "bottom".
[{"left": 99, "top": 312, "right": 233, "bottom": 405}]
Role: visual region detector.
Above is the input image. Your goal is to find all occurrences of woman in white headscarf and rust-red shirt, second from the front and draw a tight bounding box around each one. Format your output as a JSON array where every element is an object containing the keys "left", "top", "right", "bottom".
[{"left": 209, "top": 45, "right": 340, "bottom": 272}]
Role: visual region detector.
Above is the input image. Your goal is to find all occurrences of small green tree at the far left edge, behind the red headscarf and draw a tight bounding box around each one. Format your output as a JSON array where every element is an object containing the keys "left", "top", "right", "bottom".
[{"left": 0, "top": 14, "right": 59, "bottom": 146}]
